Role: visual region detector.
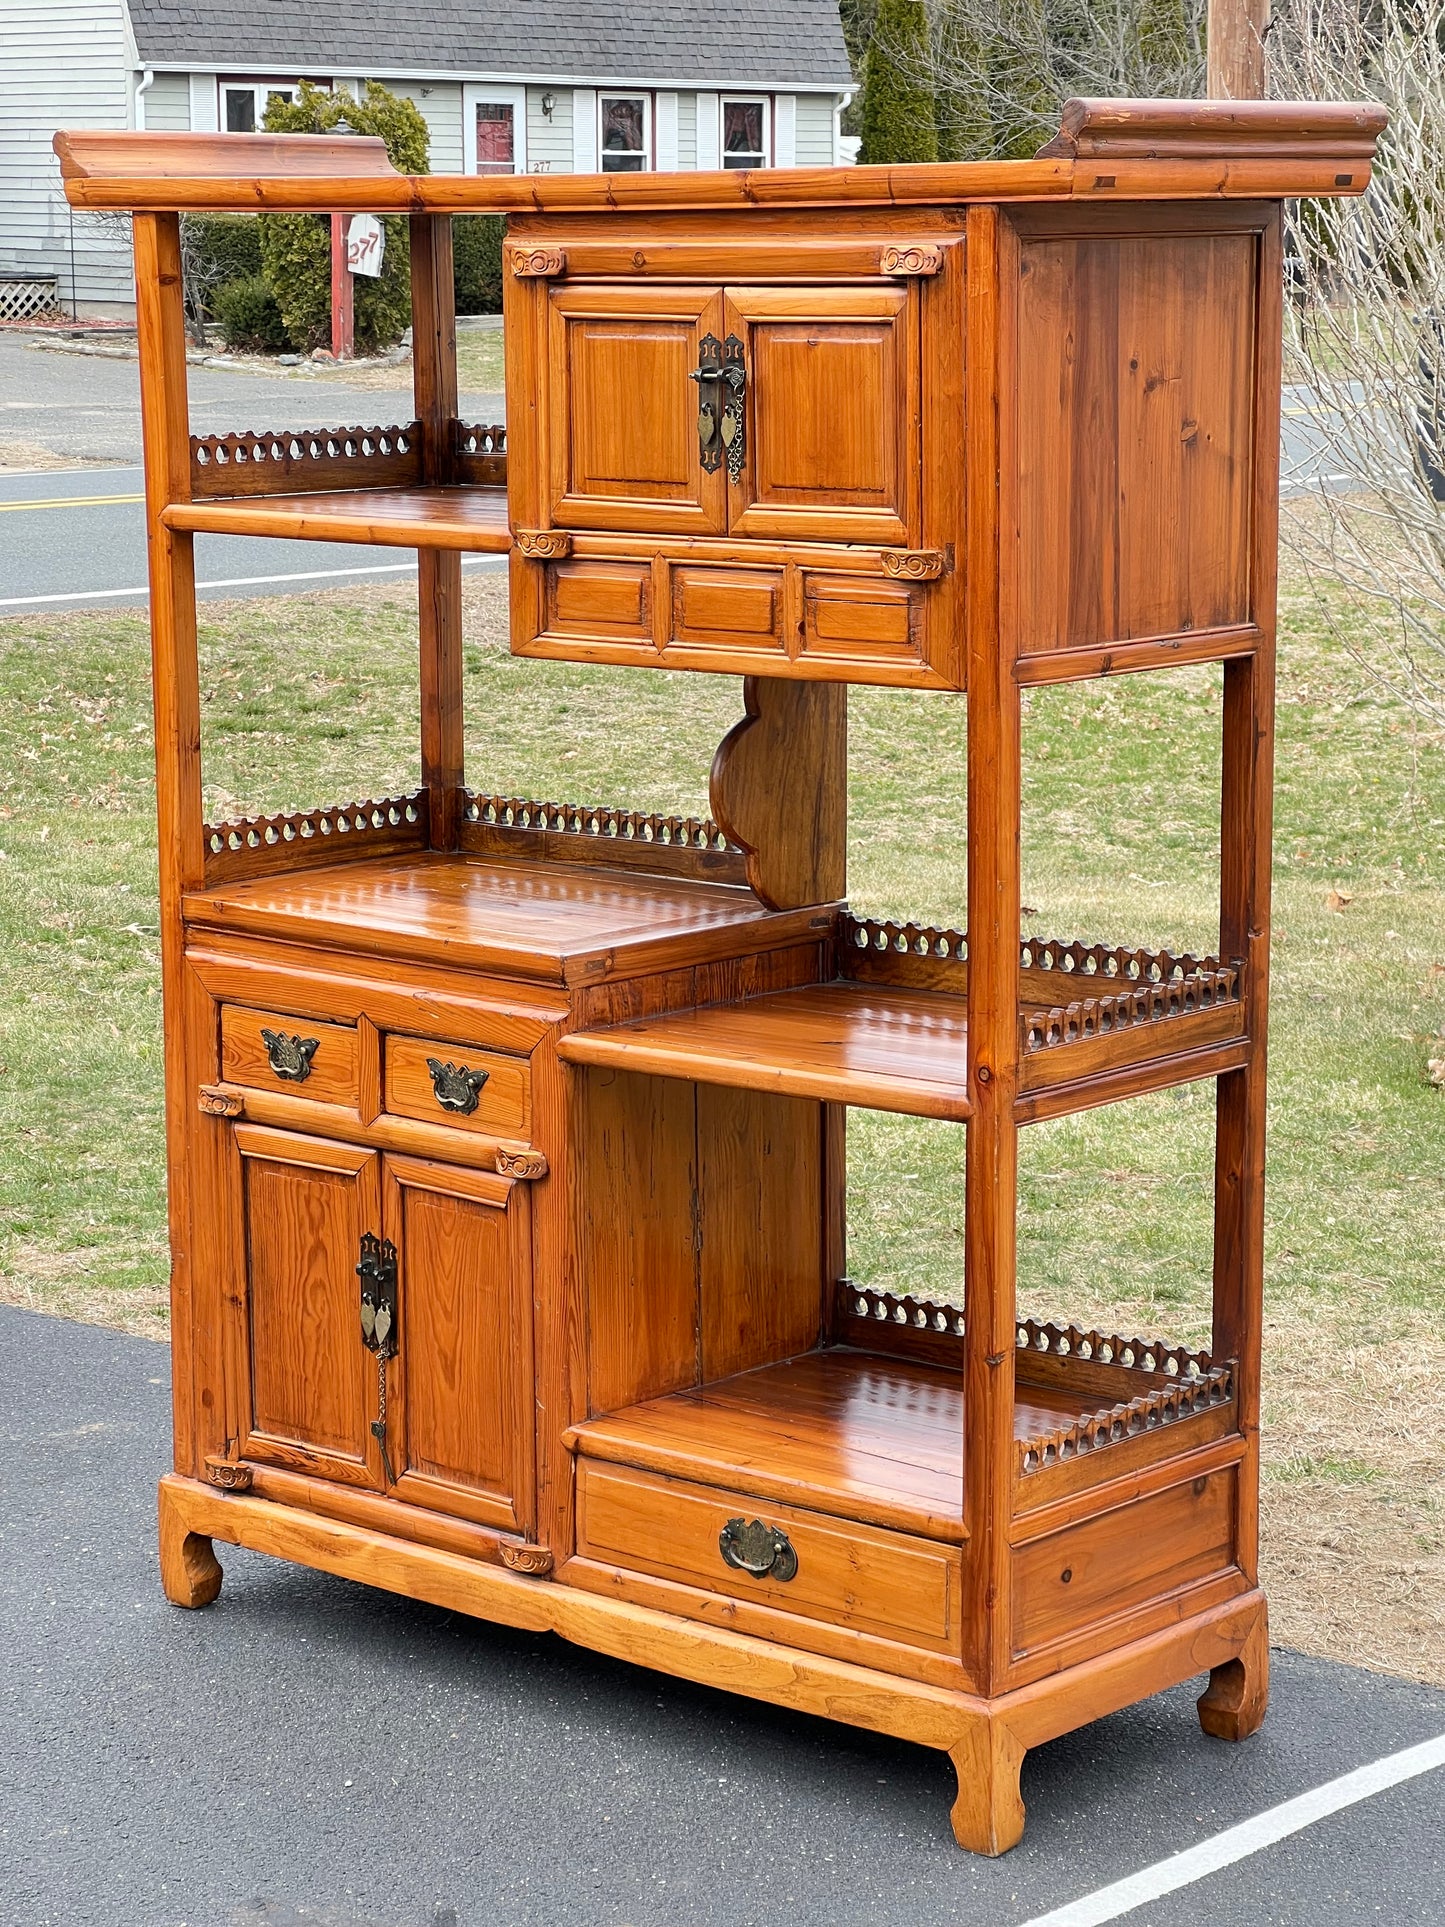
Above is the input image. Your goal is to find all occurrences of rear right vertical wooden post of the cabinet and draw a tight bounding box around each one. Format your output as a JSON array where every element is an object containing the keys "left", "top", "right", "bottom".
[{"left": 1214, "top": 204, "right": 1283, "bottom": 1580}]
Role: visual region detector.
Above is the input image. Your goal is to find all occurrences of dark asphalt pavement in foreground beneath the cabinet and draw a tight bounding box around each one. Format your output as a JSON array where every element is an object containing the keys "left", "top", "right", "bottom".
[{"left": 0, "top": 1307, "right": 1445, "bottom": 1927}]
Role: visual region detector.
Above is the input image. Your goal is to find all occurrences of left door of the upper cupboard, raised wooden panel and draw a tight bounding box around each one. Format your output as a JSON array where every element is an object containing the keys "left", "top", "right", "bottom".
[{"left": 547, "top": 287, "right": 726, "bottom": 534}]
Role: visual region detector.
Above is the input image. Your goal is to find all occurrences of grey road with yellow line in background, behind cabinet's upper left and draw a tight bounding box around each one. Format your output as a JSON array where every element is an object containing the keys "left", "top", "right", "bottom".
[{"left": 0, "top": 335, "right": 505, "bottom": 615}]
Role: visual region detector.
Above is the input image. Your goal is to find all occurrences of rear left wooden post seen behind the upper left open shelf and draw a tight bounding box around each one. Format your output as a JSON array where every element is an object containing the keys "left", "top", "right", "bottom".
[{"left": 410, "top": 214, "right": 464, "bottom": 850}]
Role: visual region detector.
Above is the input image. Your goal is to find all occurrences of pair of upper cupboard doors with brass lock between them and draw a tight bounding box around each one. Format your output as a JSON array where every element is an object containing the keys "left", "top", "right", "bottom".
[{"left": 543, "top": 283, "right": 921, "bottom": 545}]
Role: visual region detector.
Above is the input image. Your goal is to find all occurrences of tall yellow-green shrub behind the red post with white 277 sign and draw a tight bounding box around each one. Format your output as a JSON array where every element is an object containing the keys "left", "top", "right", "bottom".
[{"left": 258, "top": 81, "right": 430, "bottom": 355}]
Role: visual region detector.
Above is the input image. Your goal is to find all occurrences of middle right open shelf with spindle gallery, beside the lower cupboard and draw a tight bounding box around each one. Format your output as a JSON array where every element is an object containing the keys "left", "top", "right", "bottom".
[{"left": 559, "top": 917, "right": 1248, "bottom": 1120}]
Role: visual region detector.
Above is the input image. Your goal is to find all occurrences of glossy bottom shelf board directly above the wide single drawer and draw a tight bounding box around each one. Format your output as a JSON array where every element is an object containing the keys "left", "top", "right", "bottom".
[{"left": 570, "top": 1349, "right": 1098, "bottom": 1544}]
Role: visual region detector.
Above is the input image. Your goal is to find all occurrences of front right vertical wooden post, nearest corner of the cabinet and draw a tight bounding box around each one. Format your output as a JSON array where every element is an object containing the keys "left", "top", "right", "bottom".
[{"left": 963, "top": 206, "right": 1021, "bottom": 1694}]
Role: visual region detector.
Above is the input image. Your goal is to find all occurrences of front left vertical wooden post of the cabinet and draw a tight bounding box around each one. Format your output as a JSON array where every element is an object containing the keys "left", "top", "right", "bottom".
[{"left": 133, "top": 214, "right": 204, "bottom": 1472}]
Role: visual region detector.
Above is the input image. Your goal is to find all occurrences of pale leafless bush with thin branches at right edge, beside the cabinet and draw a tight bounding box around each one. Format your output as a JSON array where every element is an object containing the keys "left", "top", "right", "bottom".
[{"left": 1266, "top": 0, "right": 1445, "bottom": 728}]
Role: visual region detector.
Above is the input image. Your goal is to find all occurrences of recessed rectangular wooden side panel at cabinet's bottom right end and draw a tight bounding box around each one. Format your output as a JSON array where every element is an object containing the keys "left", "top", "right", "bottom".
[{"left": 1013, "top": 1466, "right": 1239, "bottom": 1651}]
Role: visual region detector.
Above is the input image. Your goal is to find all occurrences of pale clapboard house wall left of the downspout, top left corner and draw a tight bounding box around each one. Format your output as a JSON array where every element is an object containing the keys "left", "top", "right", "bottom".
[{"left": 0, "top": 0, "right": 135, "bottom": 304}]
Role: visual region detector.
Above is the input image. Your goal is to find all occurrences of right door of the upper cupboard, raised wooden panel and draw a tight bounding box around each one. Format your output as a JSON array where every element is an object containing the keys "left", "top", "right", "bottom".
[{"left": 724, "top": 287, "right": 919, "bottom": 543}]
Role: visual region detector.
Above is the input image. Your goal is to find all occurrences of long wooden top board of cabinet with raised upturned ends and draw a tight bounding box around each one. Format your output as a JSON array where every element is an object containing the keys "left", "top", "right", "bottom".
[{"left": 54, "top": 100, "right": 1385, "bottom": 216}]
